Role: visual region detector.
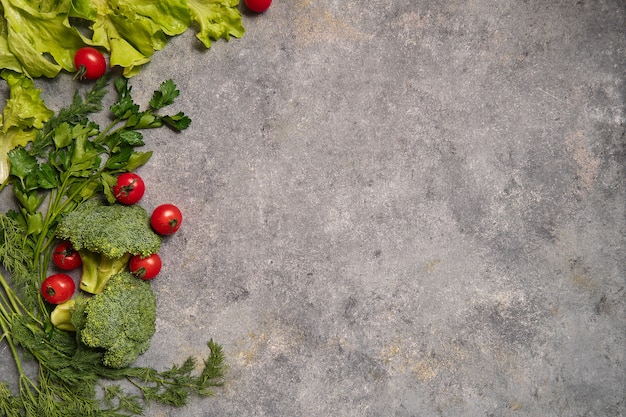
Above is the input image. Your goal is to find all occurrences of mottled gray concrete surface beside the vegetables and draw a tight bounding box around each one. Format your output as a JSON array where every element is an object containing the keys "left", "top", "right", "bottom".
[{"left": 1, "top": 0, "right": 626, "bottom": 417}]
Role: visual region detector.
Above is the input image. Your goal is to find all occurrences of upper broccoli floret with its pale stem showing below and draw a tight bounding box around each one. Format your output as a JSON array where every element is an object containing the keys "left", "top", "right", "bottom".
[{"left": 57, "top": 199, "right": 162, "bottom": 294}]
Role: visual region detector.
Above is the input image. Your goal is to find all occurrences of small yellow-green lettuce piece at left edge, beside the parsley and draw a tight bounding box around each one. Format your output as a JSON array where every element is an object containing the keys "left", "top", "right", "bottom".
[{"left": 0, "top": 71, "right": 53, "bottom": 182}]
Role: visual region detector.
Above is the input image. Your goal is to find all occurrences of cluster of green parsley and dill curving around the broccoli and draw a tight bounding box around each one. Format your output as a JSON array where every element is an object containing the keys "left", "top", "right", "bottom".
[{"left": 0, "top": 78, "right": 224, "bottom": 417}]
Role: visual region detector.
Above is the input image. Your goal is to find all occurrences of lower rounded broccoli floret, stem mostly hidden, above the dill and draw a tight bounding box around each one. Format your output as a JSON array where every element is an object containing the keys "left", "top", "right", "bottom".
[{"left": 72, "top": 272, "right": 156, "bottom": 368}]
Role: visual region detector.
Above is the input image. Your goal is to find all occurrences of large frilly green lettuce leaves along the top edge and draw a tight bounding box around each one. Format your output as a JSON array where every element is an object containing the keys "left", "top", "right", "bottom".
[{"left": 0, "top": 0, "right": 244, "bottom": 78}]
